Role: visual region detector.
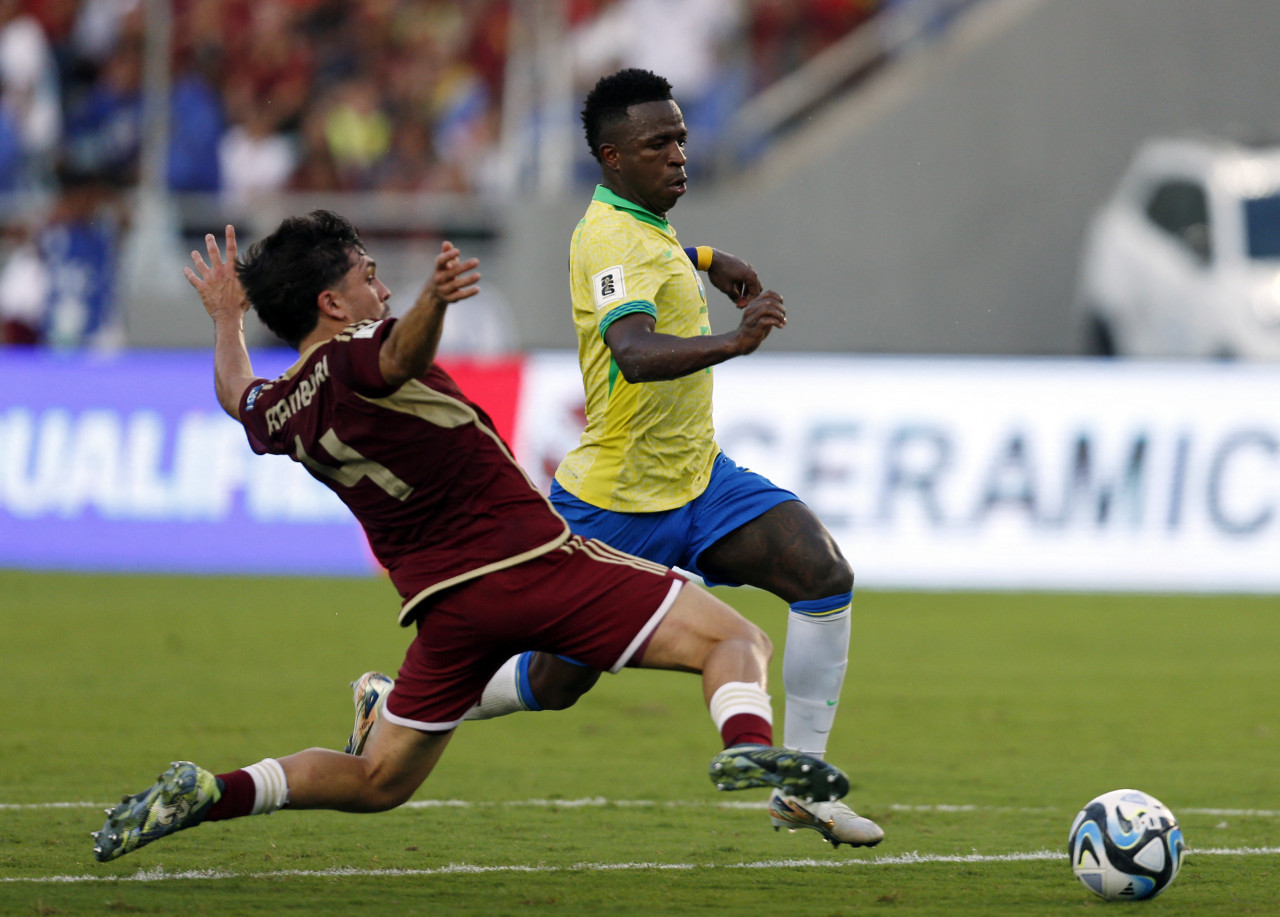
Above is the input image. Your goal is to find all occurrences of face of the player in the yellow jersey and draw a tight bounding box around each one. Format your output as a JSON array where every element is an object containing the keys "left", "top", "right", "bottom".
[{"left": 602, "top": 101, "right": 689, "bottom": 216}]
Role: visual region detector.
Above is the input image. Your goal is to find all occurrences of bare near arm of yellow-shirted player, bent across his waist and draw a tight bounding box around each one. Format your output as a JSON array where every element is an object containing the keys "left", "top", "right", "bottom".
[{"left": 604, "top": 289, "right": 787, "bottom": 383}]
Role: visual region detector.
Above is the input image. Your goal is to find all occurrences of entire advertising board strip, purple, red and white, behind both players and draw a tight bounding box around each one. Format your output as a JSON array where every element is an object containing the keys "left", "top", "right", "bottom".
[{"left": 10, "top": 352, "right": 1280, "bottom": 596}]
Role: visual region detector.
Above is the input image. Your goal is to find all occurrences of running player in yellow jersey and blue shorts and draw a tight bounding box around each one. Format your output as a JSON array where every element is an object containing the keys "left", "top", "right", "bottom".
[{"left": 356, "top": 69, "right": 884, "bottom": 847}]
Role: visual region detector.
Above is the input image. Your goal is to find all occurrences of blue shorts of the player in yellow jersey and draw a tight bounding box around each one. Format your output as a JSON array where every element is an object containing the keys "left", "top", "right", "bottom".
[{"left": 550, "top": 452, "right": 800, "bottom": 585}]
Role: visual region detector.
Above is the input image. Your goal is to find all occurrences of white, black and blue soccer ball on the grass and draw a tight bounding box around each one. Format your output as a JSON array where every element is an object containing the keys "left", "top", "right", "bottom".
[{"left": 1068, "top": 790, "right": 1187, "bottom": 902}]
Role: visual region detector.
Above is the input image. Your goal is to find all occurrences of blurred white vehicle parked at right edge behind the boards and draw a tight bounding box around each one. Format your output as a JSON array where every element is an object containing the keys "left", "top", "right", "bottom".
[{"left": 1075, "top": 138, "right": 1280, "bottom": 360}]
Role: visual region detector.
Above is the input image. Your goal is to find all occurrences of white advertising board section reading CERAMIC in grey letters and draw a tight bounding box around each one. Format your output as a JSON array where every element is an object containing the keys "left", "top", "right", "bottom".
[{"left": 516, "top": 353, "right": 1280, "bottom": 592}]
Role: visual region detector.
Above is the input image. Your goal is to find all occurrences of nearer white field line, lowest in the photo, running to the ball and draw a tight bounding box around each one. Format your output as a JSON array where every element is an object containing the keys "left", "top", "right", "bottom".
[{"left": 0, "top": 847, "right": 1280, "bottom": 885}]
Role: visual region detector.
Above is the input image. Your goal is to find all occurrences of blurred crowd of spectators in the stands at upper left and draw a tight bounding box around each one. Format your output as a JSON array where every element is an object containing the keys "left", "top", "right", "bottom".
[{"left": 0, "top": 0, "right": 893, "bottom": 346}]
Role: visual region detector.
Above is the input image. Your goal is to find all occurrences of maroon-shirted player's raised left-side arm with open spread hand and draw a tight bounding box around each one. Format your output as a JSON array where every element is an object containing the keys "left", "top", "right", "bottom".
[{"left": 182, "top": 224, "right": 256, "bottom": 420}]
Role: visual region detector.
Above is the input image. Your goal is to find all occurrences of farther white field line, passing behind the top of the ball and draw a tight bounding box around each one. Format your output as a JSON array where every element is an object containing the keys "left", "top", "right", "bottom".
[{"left": 0, "top": 797, "right": 1280, "bottom": 818}]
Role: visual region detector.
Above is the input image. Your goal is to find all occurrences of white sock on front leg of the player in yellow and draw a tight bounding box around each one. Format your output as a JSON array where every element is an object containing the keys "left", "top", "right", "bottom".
[{"left": 782, "top": 605, "right": 852, "bottom": 758}]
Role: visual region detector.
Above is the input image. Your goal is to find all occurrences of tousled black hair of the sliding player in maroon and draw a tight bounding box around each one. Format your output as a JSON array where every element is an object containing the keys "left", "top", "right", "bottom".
[{"left": 236, "top": 210, "right": 365, "bottom": 347}]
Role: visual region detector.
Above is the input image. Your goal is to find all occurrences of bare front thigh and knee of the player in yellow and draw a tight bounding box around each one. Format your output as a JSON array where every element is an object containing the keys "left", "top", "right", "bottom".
[{"left": 698, "top": 499, "right": 854, "bottom": 602}]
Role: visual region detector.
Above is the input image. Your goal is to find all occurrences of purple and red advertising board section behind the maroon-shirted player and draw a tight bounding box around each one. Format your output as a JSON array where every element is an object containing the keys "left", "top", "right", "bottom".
[{"left": 0, "top": 350, "right": 521, "bottom": 575}]
